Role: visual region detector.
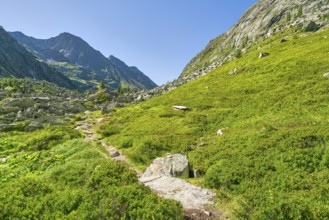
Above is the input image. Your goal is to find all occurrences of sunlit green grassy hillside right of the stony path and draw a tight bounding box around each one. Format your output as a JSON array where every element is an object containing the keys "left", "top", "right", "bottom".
[{"left": 99, "top": 29, "right": 329, "bottom": 219}]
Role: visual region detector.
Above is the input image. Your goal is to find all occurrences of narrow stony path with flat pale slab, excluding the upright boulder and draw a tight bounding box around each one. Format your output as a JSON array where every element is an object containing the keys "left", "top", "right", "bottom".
[{"left": 75, "top": 118, "right": 225, "bottom": 220}]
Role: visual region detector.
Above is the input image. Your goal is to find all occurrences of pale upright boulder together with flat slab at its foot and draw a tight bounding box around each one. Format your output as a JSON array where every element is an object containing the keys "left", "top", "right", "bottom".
[{"left": 139, "top": 154, "right": 216, "bottom": 210}]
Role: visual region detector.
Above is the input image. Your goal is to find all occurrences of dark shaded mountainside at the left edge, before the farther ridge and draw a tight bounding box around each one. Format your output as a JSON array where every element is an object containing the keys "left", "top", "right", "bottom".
[{"left": 0, "top": 27, "right": 75, "bottom": 89}]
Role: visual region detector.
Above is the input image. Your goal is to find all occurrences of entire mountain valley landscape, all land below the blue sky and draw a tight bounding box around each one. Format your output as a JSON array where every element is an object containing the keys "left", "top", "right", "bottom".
[{"left": 0, "top": 0, "right": 329, "bottom": 220}]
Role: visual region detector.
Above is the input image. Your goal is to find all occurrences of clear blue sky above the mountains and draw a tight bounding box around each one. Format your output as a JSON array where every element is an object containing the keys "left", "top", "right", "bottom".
[{"left": 0, "top": 0, "right": 257, "bottom": 84}]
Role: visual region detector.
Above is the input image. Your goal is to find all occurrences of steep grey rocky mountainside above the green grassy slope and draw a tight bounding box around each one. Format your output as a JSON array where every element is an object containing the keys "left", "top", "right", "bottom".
[{"left": 180, "top": 0, "right": 329, "bottom": 77}]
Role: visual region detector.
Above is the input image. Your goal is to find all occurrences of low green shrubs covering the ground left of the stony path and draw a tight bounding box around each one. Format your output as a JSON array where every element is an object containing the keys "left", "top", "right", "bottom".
[{"left": 0, "top": 126, "right": 183, "bottom": 219}]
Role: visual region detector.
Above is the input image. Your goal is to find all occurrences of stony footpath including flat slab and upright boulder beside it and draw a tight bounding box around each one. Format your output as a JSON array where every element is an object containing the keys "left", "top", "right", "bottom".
[{"left": 75, "top": 118, "right": 224, "bottom": 220}]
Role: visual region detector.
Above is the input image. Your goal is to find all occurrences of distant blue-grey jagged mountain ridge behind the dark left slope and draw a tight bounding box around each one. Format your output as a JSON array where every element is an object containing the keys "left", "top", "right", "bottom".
[{"left": 10, "top": 32, "right": 157, "bottom": 89}]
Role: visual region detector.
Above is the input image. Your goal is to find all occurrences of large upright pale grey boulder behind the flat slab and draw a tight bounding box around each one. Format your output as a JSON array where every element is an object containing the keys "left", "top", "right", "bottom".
[{"left": 142, "top": 154, "right": 190, "bottom": 178}]
